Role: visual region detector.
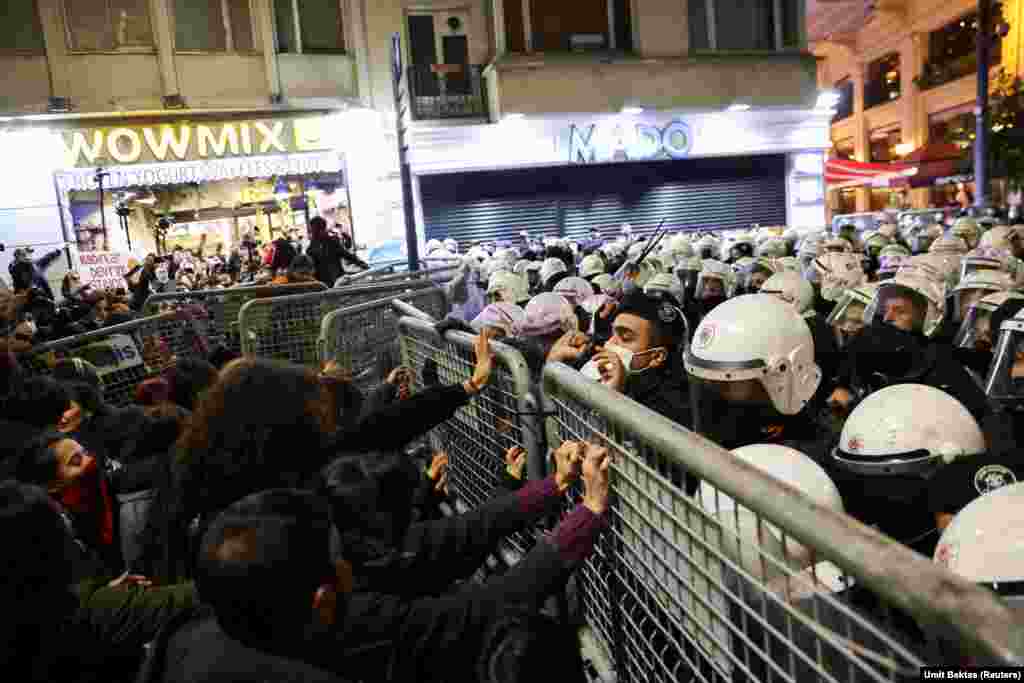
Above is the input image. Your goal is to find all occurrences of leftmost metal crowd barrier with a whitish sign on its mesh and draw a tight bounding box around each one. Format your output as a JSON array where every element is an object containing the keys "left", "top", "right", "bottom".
[{"left": 18, "top": 311, "right": 208, "bottom": 407}]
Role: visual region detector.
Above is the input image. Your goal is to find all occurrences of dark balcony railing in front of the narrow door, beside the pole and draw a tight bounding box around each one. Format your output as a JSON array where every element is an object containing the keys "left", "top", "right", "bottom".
[{"left": 409, "top": 65, "right": 487, "bottom": 121}]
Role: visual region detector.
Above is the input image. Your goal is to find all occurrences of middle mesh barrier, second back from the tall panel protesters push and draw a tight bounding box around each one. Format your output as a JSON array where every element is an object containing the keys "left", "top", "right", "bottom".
[{"left": 239, "top": 280, "right": 443, "bottom": 366}]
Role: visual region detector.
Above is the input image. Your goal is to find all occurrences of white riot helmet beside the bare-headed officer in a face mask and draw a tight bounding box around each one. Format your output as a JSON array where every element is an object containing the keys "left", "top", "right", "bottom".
[{"left": 686, "top": 294, "right": 821, "bottom": 415}]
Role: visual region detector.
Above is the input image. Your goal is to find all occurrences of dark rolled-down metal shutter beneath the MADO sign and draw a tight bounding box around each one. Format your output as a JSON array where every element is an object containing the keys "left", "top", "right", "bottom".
[{"left": 420, "top": 156, "right": 786, "bottom": 243}]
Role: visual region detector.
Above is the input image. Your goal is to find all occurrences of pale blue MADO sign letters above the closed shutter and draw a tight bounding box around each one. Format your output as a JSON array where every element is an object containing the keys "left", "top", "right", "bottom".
[{"left": 568, "top": 120, "right": 693, "bottom": 164}]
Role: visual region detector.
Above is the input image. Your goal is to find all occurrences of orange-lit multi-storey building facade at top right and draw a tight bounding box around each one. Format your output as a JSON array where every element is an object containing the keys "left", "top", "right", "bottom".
[{"left": 808, "top": 0, "right": 1024, "bottom": 219}]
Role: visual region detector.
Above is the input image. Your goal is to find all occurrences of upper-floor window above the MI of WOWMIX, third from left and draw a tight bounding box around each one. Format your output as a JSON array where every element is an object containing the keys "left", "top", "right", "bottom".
[{"left": 174, "top": 0, "right": 256, "bottom": 52}]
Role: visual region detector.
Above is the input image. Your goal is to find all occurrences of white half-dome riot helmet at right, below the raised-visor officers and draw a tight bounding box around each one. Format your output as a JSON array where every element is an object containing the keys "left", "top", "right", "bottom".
[{"left": 831, "top": 384, "right": 985, "bottom": 476}]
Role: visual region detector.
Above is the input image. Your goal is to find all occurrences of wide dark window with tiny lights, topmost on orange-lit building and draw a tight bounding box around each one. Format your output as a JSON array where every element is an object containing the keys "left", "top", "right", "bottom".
[{"left": 916, "top": 3, "right": 1002, "bottom": 90}]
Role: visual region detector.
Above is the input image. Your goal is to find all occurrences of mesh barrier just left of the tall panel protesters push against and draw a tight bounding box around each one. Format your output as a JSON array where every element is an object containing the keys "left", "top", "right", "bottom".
[{"left": 316, "top": 288, "right": 446, "bottom": 390}]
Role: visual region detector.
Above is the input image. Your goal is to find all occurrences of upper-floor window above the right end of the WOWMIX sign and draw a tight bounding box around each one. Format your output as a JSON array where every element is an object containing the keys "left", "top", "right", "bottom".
[{"left": 273, "top": 0, "right": 345, "bottom": 54}]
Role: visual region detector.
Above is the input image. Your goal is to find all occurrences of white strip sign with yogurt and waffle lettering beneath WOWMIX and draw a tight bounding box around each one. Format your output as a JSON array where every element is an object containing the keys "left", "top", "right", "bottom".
[{"left": 56, "top": 152, "right": 342, "bottom": 193}]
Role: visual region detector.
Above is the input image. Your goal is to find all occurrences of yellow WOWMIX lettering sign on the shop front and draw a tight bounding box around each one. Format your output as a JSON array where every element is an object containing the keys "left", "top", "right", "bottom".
[{"left": 62, "top": 117, "right": 331, "bottom": 167}]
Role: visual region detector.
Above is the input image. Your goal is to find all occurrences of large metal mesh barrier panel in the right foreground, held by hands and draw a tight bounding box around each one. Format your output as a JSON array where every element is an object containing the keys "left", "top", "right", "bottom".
[{"left": 544, "top": 364, "right": 1024, "bottom": 683}]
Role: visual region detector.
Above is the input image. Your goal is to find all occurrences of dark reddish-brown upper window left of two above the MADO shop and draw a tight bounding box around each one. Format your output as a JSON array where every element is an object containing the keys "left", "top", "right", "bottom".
[{"left": 528, "top": 0, "right": 632, "bottom": 52}]
